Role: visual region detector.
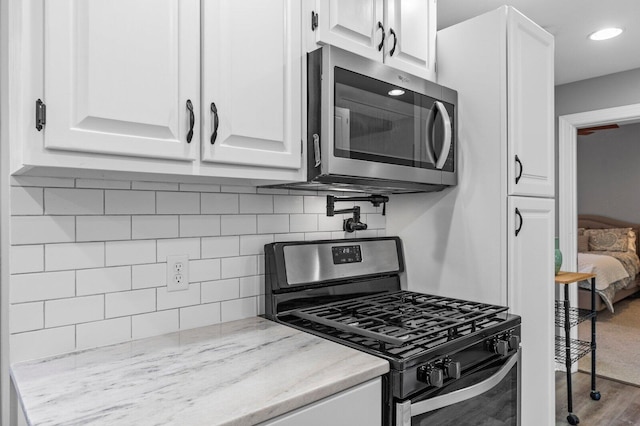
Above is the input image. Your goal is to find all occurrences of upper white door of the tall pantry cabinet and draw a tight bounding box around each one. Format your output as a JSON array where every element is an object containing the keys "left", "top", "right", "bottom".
[{"left": 507, "top": 9, "right": 555, "bottom": 197}]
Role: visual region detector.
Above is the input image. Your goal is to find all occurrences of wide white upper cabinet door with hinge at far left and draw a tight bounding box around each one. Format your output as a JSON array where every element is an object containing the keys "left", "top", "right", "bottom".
[{"left": 43, "top": 0, "right": 200, "bottom": 160}]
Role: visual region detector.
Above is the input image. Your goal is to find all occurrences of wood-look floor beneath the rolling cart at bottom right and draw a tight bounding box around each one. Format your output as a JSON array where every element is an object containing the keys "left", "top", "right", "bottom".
[{"left": 556, "top": 371, "right": 640, "bottom": 426}]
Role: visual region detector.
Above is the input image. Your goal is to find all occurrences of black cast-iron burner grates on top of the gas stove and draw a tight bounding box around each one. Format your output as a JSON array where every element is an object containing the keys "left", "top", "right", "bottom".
[{"left": 287, "top": 291, "right": 508, "bottom": 357}]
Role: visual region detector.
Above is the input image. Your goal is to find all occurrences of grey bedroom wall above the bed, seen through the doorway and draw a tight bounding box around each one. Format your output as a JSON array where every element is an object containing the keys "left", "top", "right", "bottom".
[{"left": 577, "top": 120, "right": 640, "bottom": 222}]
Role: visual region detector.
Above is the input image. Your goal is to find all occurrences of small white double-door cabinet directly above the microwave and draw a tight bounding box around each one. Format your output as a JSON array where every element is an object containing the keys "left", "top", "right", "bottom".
[{"left": 303, "top": 0, "right": 436, "bottom": 80}]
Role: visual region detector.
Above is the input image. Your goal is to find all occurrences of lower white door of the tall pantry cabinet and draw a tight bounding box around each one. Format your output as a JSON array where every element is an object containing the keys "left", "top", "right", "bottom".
[{"left": 507, "top": 197, "right": 555, "bottom": 426}]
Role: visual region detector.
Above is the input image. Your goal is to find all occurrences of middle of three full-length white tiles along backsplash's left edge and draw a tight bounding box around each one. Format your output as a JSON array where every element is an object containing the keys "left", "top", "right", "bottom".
[{"left": 9, "top": 271, "right": 76, "bottom": 303}]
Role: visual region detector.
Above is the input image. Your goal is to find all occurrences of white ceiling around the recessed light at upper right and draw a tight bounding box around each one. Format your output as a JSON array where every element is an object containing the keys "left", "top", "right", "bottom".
[{"left": 438, "top": 0, "right": 640, "bottom": 85}]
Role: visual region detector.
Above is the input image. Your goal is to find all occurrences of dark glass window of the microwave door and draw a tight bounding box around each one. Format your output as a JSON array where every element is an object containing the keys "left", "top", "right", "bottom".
[{"left": 334, "top": 67, "right": 439, "bottom": 169}]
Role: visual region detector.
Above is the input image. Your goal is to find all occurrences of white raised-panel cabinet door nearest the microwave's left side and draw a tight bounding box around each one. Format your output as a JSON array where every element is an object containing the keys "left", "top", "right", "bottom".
[{"left": 202, "top": 0, "right": 302, "bottom": 169}]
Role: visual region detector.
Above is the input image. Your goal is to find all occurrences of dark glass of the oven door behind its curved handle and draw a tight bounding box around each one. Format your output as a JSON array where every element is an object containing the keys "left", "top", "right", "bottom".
[{"left": 411, "top": 363, "right": 518, "bottom": 426}]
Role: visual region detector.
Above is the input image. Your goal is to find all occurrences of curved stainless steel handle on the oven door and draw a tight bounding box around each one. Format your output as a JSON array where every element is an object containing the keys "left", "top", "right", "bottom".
[{"left": 396, "top": 349, "right": 520, "bottom": 426}]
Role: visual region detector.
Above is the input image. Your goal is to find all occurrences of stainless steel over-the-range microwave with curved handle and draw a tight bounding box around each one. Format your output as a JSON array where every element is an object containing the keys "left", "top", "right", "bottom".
[{"left": 276, "top": 45, "right": 458, "bottom": 193}]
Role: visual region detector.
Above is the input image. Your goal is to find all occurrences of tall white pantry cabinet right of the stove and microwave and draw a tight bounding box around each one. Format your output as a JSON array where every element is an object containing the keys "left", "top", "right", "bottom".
[{"left": 387, "top": 6, "right": 555, "bottom": 426}]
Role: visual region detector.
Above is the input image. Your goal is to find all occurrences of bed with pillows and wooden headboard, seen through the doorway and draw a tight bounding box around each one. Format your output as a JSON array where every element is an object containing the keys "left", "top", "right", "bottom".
[{"left": 578, "top": 215, "right": 640, "bottom": 312}]
